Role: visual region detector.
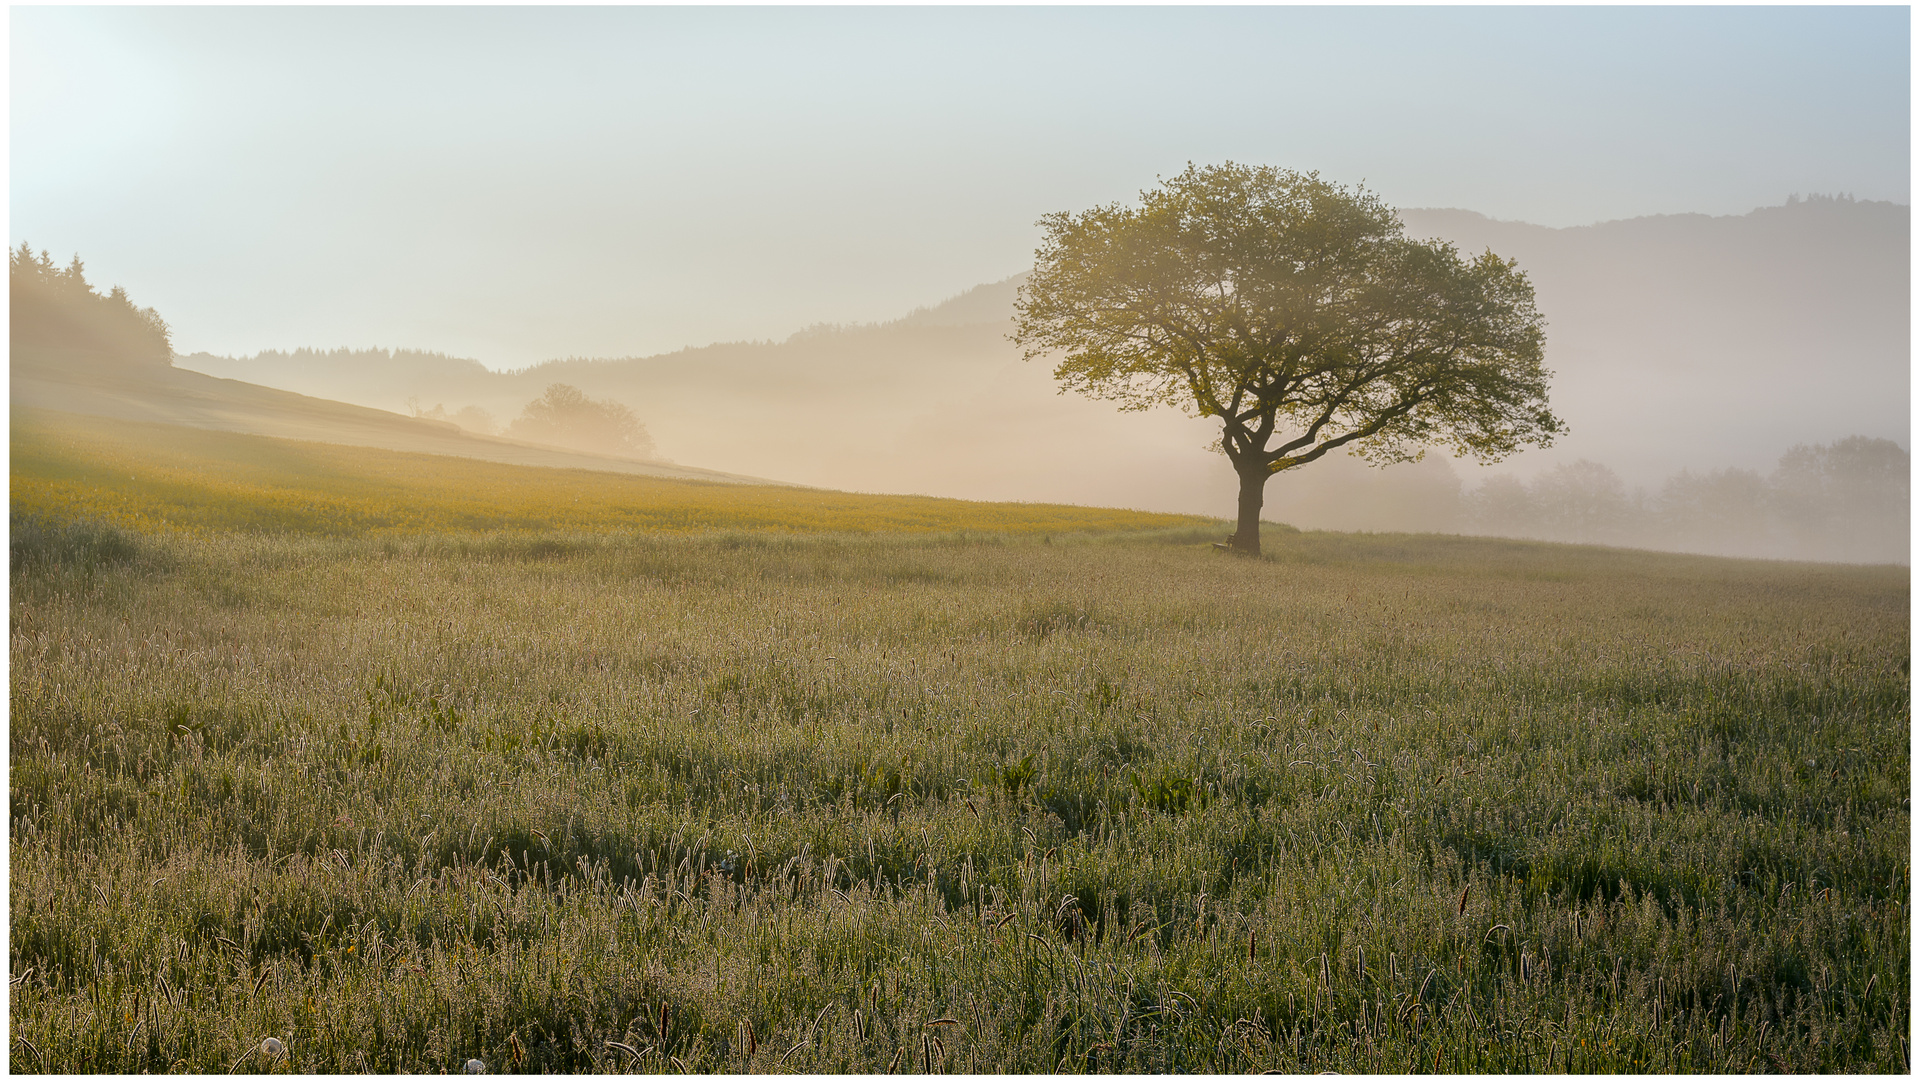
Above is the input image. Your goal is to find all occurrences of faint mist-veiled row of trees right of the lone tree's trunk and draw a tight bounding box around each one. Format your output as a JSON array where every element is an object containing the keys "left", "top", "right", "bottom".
[{"left": 1459, "top": 436, "right": 1908, "bottom": 563}]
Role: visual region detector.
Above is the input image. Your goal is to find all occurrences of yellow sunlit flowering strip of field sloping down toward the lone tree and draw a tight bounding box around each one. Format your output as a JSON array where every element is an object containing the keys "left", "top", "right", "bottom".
[{"left": 12, "top": 409, "right": 1217, "bottom": 536}]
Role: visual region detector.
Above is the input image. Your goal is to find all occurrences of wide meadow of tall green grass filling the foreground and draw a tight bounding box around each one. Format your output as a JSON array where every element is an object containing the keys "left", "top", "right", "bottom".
[{"left": 8, "top": 420, "right": 1910, "bottom": 1072}]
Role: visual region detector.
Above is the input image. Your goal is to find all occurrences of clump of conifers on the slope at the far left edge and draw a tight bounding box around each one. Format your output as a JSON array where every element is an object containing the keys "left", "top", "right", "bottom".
[{"left": 8, "top": 242, "right": 173, "bottom": 371}]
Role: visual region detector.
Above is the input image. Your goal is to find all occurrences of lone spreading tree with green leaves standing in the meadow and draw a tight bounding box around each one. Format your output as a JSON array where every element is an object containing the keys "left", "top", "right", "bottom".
[{"left": 1014, "top": 163, "right": 1565, "bottom": 553}]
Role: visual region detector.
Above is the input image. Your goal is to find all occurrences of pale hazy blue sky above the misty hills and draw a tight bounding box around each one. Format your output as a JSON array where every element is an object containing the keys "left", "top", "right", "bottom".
[{"left": 8, "top": 8, "right": 1910, "bottom": 367}]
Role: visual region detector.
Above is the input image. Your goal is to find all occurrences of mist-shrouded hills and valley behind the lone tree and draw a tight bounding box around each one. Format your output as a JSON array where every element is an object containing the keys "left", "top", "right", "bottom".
[{"left": 179, "top": 200, "right": 1910, "bottom": 563}]
